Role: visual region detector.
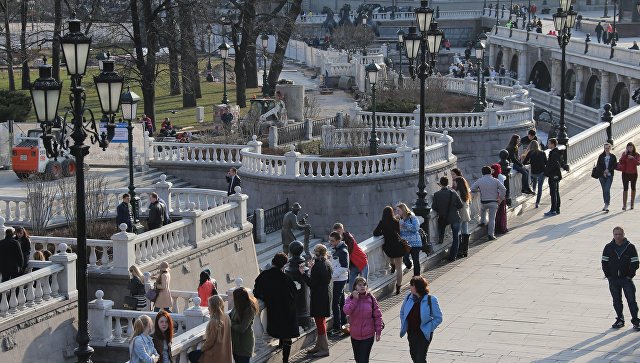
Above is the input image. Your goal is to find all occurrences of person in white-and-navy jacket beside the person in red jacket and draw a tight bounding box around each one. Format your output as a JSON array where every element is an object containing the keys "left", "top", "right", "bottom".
[{"left": 329, "top": 231, "right": 349, "bottom": 335}]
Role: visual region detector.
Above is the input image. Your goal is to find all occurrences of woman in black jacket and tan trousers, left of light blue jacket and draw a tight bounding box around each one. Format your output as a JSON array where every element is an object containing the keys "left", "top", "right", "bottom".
[{"left": 373, "top": 206, "right": 404, "bottom": 295}]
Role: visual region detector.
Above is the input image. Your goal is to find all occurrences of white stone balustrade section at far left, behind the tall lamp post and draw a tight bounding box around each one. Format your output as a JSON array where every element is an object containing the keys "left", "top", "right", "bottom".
[{"left": 0, "top": 244, "right": 78, "bottom": 323}]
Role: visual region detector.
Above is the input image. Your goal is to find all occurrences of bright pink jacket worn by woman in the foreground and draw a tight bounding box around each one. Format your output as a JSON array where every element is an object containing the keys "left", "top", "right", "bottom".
[{"left": 343, "top": 293, "right": 382, "bottom": 340}]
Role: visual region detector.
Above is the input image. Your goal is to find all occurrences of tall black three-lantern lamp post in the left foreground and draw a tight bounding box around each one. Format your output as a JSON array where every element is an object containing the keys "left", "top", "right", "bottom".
[{"left": 31, "top": 12, "right": 124, "bottom": 363}]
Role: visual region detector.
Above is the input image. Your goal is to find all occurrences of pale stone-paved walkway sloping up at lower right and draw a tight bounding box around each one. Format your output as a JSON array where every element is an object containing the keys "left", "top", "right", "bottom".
[{"left": 296, "top": 170, "right": 640, "bottom": 363}]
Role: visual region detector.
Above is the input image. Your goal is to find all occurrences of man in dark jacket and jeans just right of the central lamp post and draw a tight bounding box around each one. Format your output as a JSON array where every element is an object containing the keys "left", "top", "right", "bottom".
[{"left": 431, "top": 176, "right": 462, "bottom": 261}]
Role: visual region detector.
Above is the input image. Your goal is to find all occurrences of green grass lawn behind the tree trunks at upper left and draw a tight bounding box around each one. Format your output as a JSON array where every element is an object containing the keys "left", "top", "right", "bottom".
[{"left": 0, "top": 60, "right": 261, "bottom": 132}]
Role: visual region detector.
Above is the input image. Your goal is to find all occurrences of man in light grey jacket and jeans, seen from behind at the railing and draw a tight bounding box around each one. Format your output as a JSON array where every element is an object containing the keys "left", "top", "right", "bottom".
[{"left": 471, "top": 166, "right": 507, "bottom": 240}]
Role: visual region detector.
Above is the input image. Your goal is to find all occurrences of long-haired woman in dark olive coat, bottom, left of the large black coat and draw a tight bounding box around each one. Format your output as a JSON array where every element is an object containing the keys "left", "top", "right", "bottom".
[{"left": 229, "top": 287, "right": 259, "bottom": 363}]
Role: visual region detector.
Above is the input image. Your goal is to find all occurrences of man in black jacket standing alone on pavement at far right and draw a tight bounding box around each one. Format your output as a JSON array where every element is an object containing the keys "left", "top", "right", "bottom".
[{"left": 602, "top": 226, "right": 640, "bottom": 330}]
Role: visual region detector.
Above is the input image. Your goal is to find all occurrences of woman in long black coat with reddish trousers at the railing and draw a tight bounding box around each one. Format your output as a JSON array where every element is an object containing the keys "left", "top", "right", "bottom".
[{"left": 299, "top": 244, "right": 333, "bottom": 357}]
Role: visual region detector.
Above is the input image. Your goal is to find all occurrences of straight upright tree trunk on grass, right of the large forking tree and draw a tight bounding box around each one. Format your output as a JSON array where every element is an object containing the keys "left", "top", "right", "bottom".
[{"left": 178, "top": 0, "right": 198, "bottom": 108}]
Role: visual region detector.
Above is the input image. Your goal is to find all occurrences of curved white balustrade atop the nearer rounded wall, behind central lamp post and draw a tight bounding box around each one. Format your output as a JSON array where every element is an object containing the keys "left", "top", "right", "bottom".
[{"left": 242, "top": 132, "right": 455, "bottom": 179}]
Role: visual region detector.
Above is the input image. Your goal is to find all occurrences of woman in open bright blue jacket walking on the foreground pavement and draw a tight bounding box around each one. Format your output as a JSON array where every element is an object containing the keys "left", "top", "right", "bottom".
[{"left": 400, "top": 276, "right": 442, "bottom": 363}]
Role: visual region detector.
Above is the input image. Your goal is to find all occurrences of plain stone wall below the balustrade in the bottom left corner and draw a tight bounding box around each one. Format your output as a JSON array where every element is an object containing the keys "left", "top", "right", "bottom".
[{"left": 0, "top": 299, "right": 78, "bottom": 363}]
